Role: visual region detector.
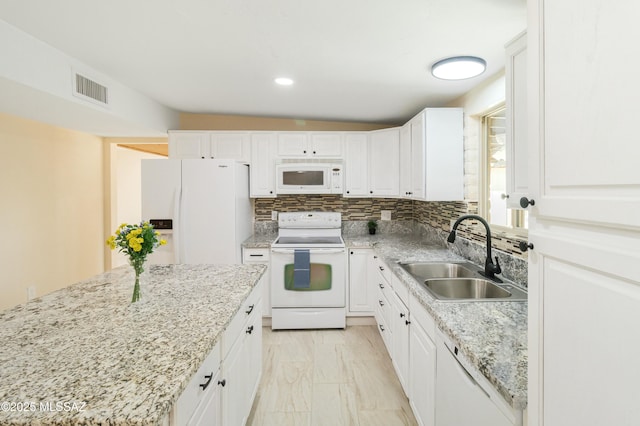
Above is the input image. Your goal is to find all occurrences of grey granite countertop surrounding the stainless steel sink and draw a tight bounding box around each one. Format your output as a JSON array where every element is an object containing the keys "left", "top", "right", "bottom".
[{"left": 343, "top": 235, "right": 527, "bottom": 410}]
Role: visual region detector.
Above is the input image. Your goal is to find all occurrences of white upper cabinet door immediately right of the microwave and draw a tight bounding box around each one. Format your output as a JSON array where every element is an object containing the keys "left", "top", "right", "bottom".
[{"left": 344, "top": 133, "right": 369, "bottom": 197}]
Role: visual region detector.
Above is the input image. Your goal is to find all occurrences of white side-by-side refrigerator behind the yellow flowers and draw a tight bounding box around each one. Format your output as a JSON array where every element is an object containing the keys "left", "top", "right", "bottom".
[{"left": 142, "top": 159, "right": 253, "bottom": 264}]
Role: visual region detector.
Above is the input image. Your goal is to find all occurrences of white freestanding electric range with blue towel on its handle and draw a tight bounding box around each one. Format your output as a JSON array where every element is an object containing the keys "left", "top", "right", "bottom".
[{"left": 271, "top": 212, "right": 347, "bottom": 330}]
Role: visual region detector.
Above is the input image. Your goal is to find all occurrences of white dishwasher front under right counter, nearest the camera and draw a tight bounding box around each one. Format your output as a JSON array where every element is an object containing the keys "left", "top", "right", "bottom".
[{"left": 436, "top": 330, "right": 522, "bottom": 426}]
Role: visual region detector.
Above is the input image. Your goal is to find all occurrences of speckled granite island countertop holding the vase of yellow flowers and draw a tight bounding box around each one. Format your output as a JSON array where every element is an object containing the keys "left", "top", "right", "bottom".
[{"left": 0, "top": 264, "right": 266, "bottom": 425}]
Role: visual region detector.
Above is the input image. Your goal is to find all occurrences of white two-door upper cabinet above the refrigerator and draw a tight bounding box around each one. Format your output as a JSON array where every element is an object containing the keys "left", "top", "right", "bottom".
[{"left": 169, "top": 131, "right": 251, "bottom": 162}]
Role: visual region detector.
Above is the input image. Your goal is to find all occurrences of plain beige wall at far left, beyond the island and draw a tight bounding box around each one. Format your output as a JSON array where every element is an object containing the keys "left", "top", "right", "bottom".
[{"left": 0, "top": 113, "right": 106, "bottom": 310}]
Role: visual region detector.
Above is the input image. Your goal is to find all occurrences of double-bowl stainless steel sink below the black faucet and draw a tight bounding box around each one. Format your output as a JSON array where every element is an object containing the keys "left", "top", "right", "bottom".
[{"left": 399, "top": 262, "right": 527, "bottom": 302}]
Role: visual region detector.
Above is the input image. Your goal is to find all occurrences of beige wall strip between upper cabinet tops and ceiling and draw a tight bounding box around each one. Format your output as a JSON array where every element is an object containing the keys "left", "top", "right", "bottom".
[{"left": 179, "top": 112, "right": 399, "bottom": 131}]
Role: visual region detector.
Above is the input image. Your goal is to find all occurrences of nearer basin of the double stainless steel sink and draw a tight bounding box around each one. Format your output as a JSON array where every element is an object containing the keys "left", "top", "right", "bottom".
[{"left": 424, "top": 278, "right": 511, "bottom": 299}]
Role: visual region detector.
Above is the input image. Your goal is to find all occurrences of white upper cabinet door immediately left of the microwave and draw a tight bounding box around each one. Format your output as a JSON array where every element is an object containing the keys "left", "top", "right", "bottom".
[{"left": 250, "top": 133, "right": 277, "bottom": 198}]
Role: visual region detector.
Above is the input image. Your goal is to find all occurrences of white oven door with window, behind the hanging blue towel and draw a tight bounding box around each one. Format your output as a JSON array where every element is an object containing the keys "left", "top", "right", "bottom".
[{"left": 271, "top": 247, "right": 347, "bottom": 308}]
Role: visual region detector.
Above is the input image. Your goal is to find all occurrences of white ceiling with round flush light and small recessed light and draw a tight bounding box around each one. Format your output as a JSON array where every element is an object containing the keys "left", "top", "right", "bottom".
[{"left": 0, "top": 0, "right": 526, "bottom": 123}]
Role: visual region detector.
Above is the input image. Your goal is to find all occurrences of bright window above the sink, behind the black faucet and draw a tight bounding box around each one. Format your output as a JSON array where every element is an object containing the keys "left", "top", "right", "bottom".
[{"left": 478, "top": 105, "right": 528, "bottom": 234}]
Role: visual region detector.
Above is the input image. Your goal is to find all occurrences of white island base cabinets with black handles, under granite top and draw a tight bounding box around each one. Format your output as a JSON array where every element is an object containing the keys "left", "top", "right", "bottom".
[{"left": 171, "top": 278, "right": 264, "bottom": 426}]
